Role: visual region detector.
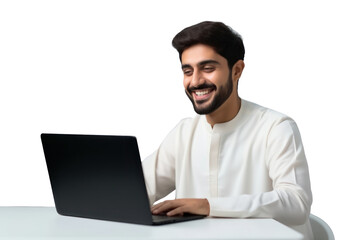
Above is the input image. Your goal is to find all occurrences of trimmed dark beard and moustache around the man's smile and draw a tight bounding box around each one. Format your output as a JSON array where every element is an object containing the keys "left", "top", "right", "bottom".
[{"left": 185, "top": 71, "right": 234, "bottom": 115}]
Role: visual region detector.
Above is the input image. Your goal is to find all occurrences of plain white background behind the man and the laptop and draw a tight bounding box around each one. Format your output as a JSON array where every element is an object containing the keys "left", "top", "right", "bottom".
[{"left": 0, "top": 0, "right": 360, "bottom": 239}]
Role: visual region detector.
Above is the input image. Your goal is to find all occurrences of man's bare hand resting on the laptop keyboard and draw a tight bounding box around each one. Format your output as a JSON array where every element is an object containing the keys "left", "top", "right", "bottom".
[{"left": 151, "top": 198, "right": 210, "bottom": 216}]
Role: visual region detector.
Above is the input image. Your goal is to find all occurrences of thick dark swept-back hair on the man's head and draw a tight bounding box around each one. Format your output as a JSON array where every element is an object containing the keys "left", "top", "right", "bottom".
[{"left": 172, "top": 21, "right": 245, "bottom": 69}]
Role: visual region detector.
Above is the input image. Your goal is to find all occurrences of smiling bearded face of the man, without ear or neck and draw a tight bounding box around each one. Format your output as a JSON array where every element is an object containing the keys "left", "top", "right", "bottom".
[{"left": 181, "top": 44, "right": 234, "bottom": 114}]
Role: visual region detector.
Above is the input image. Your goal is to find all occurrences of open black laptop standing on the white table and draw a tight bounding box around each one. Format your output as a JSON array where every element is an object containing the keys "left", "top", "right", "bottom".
[{"left": 41, "top": 133, "right": 204, "bottom": 225}]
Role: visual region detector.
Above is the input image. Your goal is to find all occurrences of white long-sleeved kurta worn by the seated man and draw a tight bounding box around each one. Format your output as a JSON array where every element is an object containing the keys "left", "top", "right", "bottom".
[{"left": 143, "top": 99, "right": 313, "bottom": 239}]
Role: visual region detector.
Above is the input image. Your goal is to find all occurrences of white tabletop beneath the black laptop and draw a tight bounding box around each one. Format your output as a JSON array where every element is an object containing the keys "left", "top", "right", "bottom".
[{"left": 0, "top": 207, "right": 303, "bottom": 240}]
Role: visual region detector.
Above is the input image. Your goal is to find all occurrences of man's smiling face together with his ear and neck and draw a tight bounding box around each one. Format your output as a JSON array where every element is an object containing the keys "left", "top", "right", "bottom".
[{"left": 181, "top": 44, "right": 244, "bottom": 125}]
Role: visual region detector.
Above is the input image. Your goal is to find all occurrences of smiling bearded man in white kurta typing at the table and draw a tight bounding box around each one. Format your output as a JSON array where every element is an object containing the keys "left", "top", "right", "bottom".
[{"left": 143, "top": 22, "right": 312, "bottom": 239}]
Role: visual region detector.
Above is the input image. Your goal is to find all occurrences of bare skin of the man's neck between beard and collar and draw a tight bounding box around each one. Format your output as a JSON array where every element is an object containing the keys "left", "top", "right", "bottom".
[{"left": 206, "top": 95, "right": 241, "bottom": 128}]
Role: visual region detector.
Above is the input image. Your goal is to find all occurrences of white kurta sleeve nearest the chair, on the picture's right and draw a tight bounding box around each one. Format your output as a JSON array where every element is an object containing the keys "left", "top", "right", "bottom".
[{"left": 208, "top": 119, "right": 312, "bottom": 225}]
